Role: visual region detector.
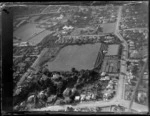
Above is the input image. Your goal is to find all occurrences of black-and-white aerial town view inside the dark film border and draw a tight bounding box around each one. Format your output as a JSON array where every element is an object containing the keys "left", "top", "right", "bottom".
[{"left": 13, "top": 1, "right": 149, "bottom": 113}]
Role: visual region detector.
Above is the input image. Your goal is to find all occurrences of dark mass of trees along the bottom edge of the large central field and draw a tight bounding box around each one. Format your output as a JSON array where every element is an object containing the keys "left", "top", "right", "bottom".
[{"left": 14, "top": 68, "right": 99, "bottom": 107}]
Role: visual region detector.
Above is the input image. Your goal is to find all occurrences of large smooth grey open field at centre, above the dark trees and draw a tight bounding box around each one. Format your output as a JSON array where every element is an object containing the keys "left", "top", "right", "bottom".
[{"left": 47, "top": 43, "right": 101, "bottom": 71}]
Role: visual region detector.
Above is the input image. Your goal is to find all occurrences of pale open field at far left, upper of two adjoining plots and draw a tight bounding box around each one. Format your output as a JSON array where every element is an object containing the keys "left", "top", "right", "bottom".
[{"left": 14, "top": 23, "right": 44, "bottom": 42}]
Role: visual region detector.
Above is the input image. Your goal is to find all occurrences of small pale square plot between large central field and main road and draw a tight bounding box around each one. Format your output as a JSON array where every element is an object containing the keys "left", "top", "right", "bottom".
[{"left": 106, "top": 44, "right": 120, "bottom": 55}]
